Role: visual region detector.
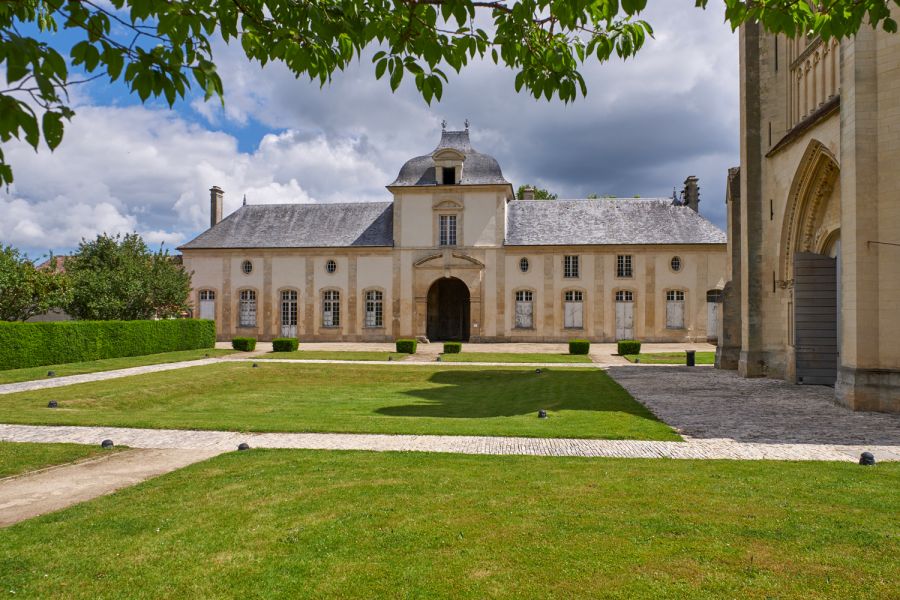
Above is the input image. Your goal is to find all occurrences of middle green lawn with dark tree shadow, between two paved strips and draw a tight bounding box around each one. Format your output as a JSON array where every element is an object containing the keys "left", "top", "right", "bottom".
[{"left": 0, "top": 361, "right": 681, "bottom": 440}]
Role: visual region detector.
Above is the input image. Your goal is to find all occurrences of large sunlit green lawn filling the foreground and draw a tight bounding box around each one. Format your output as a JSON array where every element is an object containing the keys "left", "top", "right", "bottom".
[{"left": 0, "top": 450, "right": 900, "bottom": 600}]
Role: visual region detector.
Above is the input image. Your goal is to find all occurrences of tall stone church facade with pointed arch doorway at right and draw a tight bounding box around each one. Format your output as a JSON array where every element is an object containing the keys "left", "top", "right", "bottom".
[{"left": 718, "top": 19, "right": 900, "bottom": 412}]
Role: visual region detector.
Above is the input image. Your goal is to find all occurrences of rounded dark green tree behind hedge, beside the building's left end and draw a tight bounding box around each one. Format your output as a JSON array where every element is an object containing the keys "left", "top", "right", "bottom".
[{"left": 66, "top": 233, "right": 191, "bottom": 321}]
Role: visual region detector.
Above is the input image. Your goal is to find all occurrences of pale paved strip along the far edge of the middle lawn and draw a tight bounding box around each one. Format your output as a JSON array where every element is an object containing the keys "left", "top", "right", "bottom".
[{"left": 0, "top": 356, "right": 598, "bottom": 395}]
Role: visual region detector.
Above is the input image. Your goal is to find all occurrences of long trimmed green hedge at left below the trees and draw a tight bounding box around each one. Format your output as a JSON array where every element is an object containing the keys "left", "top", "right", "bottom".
[{"left": 0, "top": 319, "right": 216, "bottom": 370}]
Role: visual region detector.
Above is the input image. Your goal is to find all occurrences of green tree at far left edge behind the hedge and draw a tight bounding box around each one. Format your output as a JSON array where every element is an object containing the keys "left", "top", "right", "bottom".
[{"left": 0, "top": 246, "right": 69, "bottom": 321}]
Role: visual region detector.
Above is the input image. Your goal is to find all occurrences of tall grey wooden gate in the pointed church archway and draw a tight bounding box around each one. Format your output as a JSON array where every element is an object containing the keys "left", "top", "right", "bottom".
[{"left": 794, "top": 252, "right": 838, "bottom": 385}]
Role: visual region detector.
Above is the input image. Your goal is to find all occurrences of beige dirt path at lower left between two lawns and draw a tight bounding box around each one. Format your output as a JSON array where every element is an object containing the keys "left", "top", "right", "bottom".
[{"left": 0, "top": 448, "right": 222, "bottom": 527}]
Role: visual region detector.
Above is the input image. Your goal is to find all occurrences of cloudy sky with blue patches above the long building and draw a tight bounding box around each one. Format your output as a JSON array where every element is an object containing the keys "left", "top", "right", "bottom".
[{"left": 0, "top": 0, "right": 739, "bottom": 257}]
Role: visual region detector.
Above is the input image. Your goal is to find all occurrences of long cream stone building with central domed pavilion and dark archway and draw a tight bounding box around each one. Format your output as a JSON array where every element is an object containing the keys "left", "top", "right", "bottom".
[{"left": 180, "top": 129, "right": 726, "bottom": 342}]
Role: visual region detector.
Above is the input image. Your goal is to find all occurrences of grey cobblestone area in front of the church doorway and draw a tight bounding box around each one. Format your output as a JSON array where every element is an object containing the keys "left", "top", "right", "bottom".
[{"left": 607, "top": 366, "right": 900, "bottom": 449}]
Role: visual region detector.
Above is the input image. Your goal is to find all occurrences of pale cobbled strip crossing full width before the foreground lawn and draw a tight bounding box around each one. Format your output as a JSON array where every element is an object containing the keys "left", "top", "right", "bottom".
[{"left": 0, "top": 425, "right": 900, "bottom": 461}]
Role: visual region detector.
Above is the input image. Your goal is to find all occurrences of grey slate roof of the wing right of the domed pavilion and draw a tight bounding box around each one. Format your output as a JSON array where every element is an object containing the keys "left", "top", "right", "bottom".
[{"left": 506, "top": 198, "right": 727, "bottom": 246}]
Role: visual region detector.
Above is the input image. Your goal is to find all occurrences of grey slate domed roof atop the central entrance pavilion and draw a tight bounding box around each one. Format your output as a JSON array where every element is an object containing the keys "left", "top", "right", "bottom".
[{"left": 388, "top": 129, "right": 510, "bottom": 187}]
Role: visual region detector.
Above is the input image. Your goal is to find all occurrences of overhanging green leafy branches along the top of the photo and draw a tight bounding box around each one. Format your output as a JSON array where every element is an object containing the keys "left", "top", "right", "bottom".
[{"left": 0, "top": 0, "right": 900, "bottom": 184}]
